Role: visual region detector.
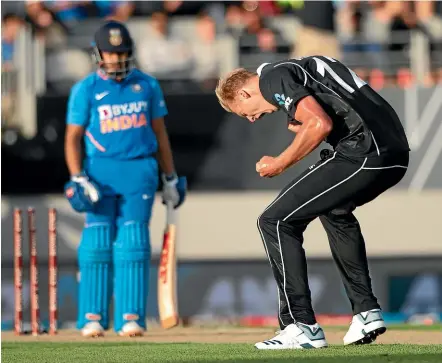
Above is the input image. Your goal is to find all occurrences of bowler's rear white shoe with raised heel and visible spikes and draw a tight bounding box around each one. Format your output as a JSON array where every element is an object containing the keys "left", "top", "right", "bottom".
[{"left": 344, "top": 309, "right": 387, "bottom": 345}]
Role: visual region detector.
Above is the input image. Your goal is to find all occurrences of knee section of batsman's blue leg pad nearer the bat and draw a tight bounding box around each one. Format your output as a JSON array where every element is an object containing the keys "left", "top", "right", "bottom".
[{"left": 114, "top": 221, "right": 150, "bottom": 263}]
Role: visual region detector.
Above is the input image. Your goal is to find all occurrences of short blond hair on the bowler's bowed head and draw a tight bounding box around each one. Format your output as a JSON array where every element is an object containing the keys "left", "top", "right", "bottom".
[{"left": 215, "top": 68, "right": 256, "bottom": 112}]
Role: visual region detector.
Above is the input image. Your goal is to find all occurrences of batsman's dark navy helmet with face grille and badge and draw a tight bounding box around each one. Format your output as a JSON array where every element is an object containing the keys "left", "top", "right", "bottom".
[{"left": 92, "top": 20, "right": 135, "bottom": 79}]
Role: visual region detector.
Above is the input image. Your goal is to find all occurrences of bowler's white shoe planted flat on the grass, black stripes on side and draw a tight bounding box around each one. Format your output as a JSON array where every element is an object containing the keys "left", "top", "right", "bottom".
[{"left": 255, "top": 323, "right": 328, "bottom": 349}]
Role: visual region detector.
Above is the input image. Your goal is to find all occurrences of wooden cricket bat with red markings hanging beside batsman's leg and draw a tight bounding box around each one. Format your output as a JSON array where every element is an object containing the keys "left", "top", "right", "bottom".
[{"left": 158, "top": 203, "right": 179, "bottom": 329}]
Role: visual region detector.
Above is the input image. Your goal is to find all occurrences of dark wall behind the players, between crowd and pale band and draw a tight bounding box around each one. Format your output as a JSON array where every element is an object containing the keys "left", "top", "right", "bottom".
[{"left": 2, "top": 88, "right": 442, "bottom": 194}]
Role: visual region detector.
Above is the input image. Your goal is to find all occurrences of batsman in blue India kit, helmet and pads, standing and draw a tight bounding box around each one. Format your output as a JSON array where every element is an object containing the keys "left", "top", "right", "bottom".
[{"left": 65, "top": 21, "right": 186, "bottom": 336}]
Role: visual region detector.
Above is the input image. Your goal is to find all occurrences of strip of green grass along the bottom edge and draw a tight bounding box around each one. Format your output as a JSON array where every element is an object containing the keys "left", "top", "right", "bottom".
[{"left": 1, "top": 342, "right": 442, "bottom": 363}]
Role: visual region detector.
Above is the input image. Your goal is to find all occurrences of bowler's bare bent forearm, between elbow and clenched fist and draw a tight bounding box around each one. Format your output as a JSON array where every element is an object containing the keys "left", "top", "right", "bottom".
[{"left": 277, "top": 121, "right": 329, "bottom": 168}]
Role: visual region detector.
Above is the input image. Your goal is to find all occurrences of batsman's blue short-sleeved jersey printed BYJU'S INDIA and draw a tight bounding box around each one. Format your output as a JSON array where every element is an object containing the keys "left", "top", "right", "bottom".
[{"left": 66, "top": 70, "right": 167, "bottom": 160}]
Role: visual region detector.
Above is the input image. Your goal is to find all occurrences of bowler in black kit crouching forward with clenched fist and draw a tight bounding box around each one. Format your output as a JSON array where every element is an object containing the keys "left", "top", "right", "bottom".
[{"left": 216, "top": 56, "right": 410, "bottom": 349}]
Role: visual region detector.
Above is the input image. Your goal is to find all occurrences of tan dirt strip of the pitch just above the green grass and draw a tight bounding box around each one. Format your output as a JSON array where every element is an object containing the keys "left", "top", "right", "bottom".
[{"left": 2, "top": 327, "right": 442, "bottom": 344}]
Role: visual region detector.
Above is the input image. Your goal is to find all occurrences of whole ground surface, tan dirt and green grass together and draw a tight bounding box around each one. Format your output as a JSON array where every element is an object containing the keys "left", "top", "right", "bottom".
[{"left": 1, "top": 324, "right": 442, "bottom": 363}]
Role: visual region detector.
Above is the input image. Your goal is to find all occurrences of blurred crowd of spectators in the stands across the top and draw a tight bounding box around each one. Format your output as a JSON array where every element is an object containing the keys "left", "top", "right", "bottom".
[{"left": 2, "top": 0, "right": 442, "bottom": 94}]
